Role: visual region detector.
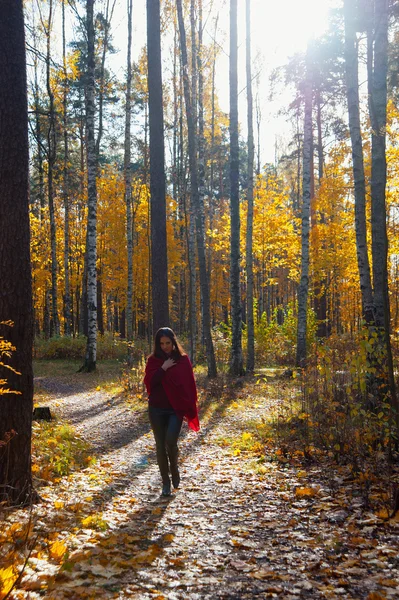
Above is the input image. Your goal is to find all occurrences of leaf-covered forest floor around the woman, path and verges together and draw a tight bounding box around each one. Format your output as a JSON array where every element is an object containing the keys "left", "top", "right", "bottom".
[{"left": 0, "top": 362, "right": 399, "bottom": 600}]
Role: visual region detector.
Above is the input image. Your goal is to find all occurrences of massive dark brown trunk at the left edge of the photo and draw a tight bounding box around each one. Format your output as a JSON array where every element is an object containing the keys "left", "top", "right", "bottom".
[{"left": 0, "top": 0, "right": 33, "bottom": 504}]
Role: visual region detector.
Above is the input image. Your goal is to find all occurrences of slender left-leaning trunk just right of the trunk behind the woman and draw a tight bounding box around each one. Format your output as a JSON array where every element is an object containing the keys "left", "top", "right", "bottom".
[{"left": 176, "top": 0, "right": 217, "bottom": 377}]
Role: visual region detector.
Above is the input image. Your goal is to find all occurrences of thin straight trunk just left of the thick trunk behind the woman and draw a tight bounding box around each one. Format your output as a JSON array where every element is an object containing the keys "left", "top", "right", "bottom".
[{"left": 124, "top": 0, "right": 133, "bottom": 349}]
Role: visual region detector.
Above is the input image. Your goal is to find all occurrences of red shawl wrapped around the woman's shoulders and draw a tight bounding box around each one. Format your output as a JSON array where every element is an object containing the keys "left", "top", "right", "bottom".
[{"left": 144, "top": 354, "right": 200, "bottom": 431}]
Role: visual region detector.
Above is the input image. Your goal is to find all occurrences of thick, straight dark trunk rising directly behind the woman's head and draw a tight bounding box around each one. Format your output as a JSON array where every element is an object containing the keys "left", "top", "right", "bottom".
[{"left": 147, "top": 0, "right": 169, "bottom": 331}]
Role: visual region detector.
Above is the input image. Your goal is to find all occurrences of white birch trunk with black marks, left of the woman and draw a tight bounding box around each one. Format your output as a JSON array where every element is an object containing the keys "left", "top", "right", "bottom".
[{"left": 82, "top": 0, "right": 97, "bottom": 372}]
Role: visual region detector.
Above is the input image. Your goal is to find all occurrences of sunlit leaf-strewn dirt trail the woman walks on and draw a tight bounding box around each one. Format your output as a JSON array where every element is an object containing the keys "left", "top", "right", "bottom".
[{"left": 15, "top": 377, "right": 399, "bottom": 600}]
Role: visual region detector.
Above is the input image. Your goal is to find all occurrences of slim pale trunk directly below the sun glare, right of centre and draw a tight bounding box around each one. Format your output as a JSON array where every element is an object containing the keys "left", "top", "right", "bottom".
[{"left": 296, "top": 48, "right": 313, "bottom": 367}]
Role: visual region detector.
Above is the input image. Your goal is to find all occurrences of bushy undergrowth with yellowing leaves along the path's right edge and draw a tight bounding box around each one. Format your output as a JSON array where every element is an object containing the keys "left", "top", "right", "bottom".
[{"left": 219, "top": 339, "right": 399, "bottom": 519}]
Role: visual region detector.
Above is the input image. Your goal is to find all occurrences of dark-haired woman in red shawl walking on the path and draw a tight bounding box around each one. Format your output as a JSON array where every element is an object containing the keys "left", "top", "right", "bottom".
[{"left": 144, "top": 327, "right": 200, "bottom": 496}]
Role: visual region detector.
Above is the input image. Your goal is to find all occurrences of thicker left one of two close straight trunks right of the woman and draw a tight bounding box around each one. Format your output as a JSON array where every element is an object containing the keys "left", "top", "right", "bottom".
[{"left": 230, "top": 0, "right": 244, "bottom": 375}]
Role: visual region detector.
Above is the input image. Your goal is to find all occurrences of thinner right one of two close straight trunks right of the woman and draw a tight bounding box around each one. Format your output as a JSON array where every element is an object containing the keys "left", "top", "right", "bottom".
[{"left": 246, "top": 0, "right": 255, "bottom": 373}]
